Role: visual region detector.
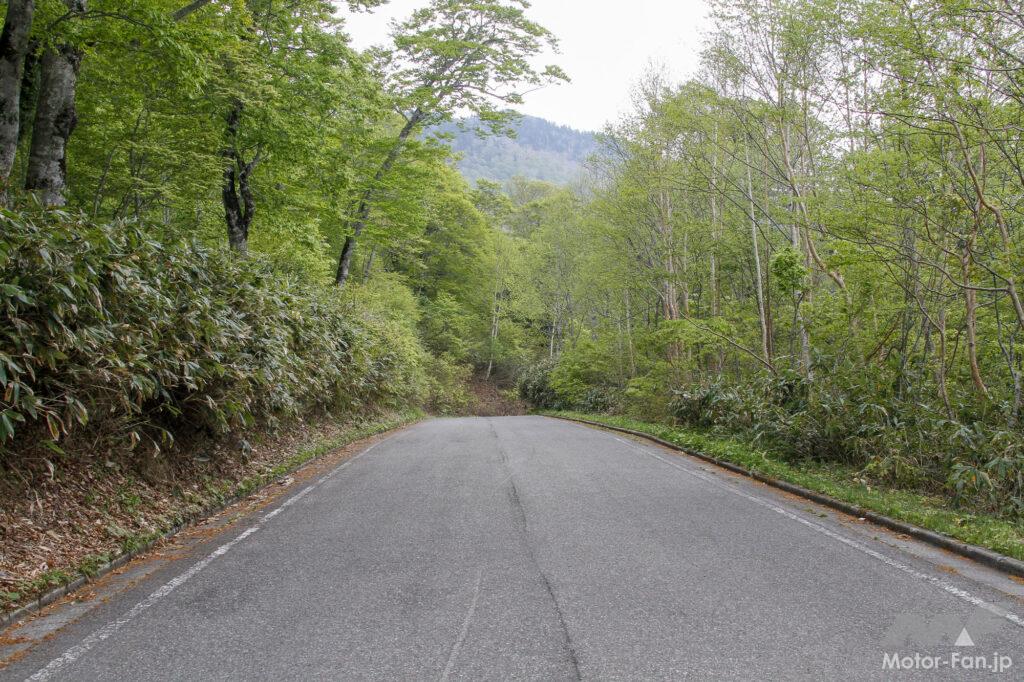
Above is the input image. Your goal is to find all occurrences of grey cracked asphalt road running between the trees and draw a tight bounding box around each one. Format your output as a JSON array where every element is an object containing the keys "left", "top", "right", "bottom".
[{"left": 0, "top": 417, "right": 1024, "bottom": 680}]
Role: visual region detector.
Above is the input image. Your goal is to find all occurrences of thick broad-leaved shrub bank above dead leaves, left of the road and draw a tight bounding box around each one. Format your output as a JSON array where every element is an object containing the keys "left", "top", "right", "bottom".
[{"left": 0, "top": 206, "right": 425, "bottom": 457}]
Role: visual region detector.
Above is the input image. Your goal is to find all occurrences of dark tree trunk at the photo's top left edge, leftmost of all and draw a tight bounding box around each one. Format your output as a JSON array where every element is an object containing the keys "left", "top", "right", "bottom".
[{"left": 0, "top": 0, "right": 36, "bottom": 193}]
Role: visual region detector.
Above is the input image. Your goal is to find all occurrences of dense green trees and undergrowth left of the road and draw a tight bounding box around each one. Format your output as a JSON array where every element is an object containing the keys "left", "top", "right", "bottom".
[{"left": 0, "top": 0, "right": 565, "bottom": 466}]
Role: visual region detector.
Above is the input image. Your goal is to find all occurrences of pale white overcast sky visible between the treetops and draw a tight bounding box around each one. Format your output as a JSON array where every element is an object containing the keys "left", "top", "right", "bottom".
[{"left": 344, "top": 0, "right": 708, "bottom": 130}]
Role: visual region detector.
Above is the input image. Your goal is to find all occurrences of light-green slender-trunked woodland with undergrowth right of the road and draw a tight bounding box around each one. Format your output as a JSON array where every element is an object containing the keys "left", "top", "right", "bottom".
[{"left": 516, "top": 0, "right": 1024, "bottom": 517}]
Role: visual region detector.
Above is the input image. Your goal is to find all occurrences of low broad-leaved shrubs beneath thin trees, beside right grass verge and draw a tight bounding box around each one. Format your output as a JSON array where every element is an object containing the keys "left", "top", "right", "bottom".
[{"left": 672, "top": 368, "right": 1024, "bottom": 515}]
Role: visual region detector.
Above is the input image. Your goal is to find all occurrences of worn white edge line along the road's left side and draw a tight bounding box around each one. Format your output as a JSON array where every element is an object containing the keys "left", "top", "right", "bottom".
[{"left": 26, "top": 436, "right": 392, "bottom": 682}]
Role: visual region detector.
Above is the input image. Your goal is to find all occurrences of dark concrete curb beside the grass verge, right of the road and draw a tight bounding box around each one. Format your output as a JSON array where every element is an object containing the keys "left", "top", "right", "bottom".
[{"left": 545, "top": 415, "right": 1024, "bottom": 578}]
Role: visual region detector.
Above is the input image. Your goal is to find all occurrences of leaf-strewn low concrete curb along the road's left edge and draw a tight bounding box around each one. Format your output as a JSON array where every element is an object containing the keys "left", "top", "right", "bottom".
[{"left": 0, "top": 411, "right": 422, "bottom": 630}]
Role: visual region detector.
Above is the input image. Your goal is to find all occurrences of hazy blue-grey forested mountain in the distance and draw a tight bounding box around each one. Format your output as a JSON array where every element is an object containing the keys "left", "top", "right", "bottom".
[{"left": 438, "top": 116, "right": 597, "bottom": 184}]
